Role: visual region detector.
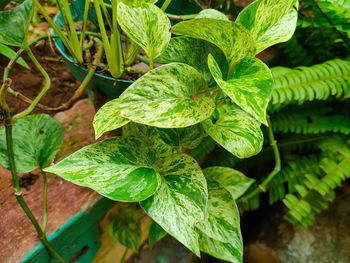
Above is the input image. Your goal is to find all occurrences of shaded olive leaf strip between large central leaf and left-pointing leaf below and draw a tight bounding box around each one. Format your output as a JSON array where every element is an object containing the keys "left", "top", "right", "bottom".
[{"left": 123, "top": 122, "right": 178, "bottom": 159}]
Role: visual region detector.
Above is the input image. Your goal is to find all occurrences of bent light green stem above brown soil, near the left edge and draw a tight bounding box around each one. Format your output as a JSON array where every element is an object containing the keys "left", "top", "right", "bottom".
[{"left": 12, "top": 48, "right": 51, "bottom": 123}]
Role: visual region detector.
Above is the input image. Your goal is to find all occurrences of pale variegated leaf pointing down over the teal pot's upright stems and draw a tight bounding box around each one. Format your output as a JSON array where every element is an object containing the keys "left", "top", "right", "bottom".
[{"left": 118, "top": 3, "right": 171, "bottom": 59}]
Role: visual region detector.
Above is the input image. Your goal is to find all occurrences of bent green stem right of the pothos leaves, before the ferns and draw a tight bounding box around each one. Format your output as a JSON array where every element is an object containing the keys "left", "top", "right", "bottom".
[{"left": 242, "top": 117, "right": 281, "bottom": 200}]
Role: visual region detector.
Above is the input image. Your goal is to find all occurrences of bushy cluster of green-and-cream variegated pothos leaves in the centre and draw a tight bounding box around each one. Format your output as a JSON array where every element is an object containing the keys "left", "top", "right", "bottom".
[{"left": 45, "top": 0, "right": 297, "bottom": 262}]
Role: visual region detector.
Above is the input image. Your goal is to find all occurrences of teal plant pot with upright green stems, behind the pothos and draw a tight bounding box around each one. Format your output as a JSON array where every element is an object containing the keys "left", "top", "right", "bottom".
[{"left": 53, "top": 0, "right": 201, "bottom": 100}]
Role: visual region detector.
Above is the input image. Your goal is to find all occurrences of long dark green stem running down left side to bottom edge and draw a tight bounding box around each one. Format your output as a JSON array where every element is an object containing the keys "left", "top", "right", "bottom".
[{"left": 5, "top": 125, "right": 65, "bottom": 263}]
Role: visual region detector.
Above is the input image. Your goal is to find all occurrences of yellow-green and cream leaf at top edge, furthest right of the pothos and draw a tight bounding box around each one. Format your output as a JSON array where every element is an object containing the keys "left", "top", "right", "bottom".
[{"left": 236, "top": 0, "right": 297, "bottom": 52}]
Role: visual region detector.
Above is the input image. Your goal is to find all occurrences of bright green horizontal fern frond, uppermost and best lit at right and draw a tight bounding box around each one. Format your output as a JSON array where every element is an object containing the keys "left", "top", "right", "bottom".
[{"left": 270, "top": 59, "right": 350, "bottom": 111}]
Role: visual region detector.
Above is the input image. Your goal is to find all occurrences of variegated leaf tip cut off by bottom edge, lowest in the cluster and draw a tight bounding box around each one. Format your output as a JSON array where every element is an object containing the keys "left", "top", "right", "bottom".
[{"left": 199, "top": 232, "right": 243, "bottom": 263}]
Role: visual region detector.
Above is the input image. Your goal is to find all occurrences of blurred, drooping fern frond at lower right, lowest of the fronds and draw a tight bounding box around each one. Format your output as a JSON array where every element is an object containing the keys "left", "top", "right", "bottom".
[{"left": 283, "top": 137, "right": 350, "bottom": 228}]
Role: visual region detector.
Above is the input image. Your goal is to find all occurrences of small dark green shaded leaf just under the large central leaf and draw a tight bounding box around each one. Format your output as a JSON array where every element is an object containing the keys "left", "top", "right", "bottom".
[{"left": 158, "top": 124, "right": 207, "bottom": 152}]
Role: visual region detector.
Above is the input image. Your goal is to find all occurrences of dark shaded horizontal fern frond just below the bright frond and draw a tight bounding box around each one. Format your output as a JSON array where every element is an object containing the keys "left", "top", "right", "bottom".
[{"left": 271, "top": 110, "right": 350, "bottom": 134}]
